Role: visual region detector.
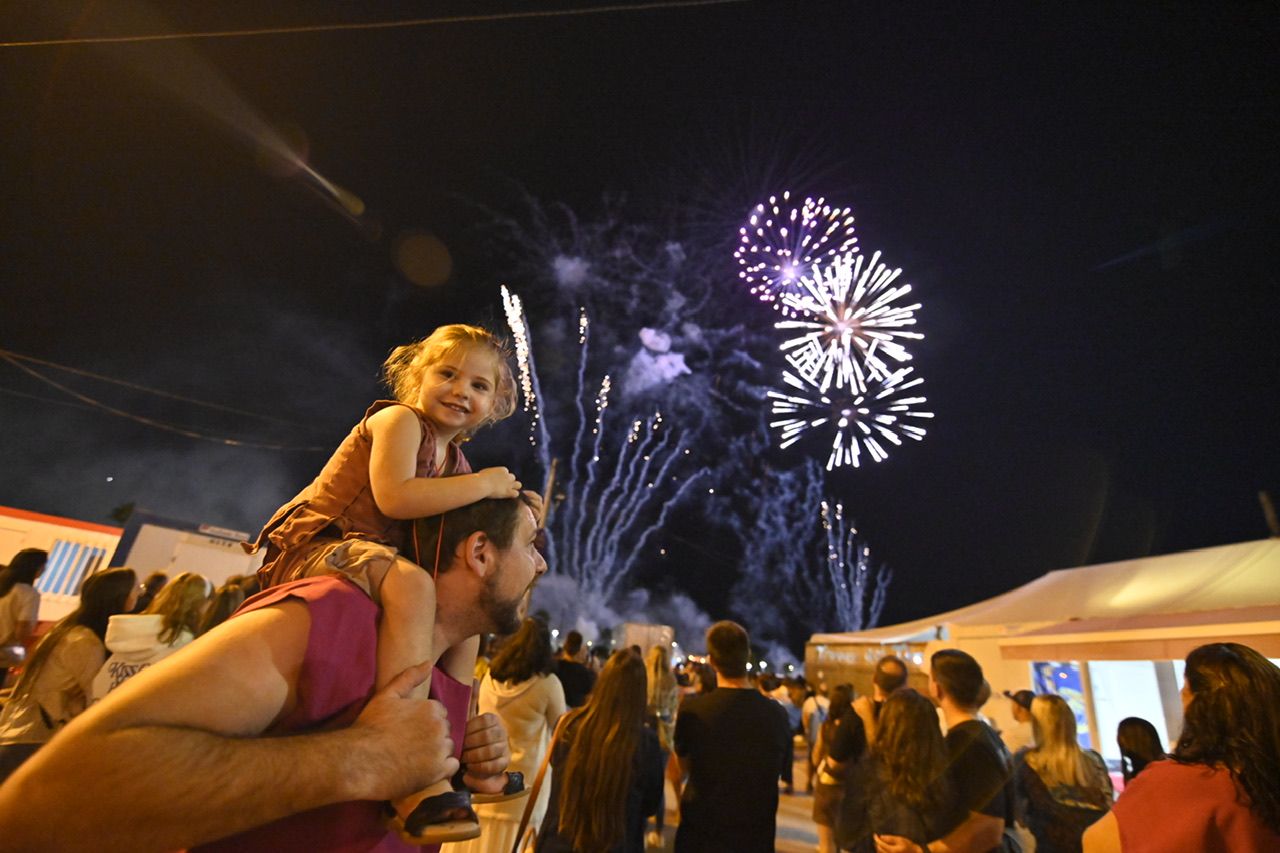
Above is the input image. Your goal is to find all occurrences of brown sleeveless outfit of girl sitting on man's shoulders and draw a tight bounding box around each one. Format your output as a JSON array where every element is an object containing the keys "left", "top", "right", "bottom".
[{"left": 246, "top": 400, "right": 471, "bottom": 601}]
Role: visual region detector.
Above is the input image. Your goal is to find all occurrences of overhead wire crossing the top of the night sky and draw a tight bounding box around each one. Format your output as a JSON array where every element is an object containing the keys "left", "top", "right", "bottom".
[{"left": 0, "top": 0, "right": 750, "bottom": 47}]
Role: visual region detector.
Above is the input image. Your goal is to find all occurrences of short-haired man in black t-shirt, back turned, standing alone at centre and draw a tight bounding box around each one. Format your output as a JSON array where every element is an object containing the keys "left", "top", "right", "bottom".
[{"left": 675, "top": 621, "right": 791, "bottom": 853}]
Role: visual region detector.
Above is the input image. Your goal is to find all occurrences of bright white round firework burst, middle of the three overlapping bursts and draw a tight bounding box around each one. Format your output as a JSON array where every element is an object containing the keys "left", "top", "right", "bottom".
[{"left": 774, "top": 252, "right": 924, "bottom": 393}]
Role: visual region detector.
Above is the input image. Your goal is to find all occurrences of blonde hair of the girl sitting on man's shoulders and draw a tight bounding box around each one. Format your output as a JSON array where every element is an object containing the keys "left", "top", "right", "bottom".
[{"left": 383, "top": 323, "right": 517, "bottom": 439}]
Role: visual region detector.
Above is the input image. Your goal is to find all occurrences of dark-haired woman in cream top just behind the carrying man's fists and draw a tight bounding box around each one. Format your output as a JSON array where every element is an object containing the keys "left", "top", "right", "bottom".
[{"left": 449, "top": 619, "right": 564, "bottom": 853}]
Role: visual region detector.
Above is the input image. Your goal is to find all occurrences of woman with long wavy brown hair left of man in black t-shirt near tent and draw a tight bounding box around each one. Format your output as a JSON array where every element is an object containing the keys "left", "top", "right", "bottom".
[{"left": 836, "top": 688, "right": 968, "bottom": 853}]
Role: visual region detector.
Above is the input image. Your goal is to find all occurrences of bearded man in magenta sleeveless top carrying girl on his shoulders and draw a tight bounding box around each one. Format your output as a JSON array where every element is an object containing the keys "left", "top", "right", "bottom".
[{"left": 0, "top": 497, "right": 547, "bottom": 853}]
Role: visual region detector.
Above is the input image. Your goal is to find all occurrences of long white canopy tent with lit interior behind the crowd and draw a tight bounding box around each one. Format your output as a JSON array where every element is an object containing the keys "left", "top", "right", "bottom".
[{"left": 805, "top": 539, "right": 1280, "bottom": 758}]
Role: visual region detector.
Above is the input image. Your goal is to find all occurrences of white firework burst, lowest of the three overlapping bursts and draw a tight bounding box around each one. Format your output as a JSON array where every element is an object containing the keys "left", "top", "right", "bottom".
[{"left": 768, "top": 368, "right": 933, "bottom": 471}]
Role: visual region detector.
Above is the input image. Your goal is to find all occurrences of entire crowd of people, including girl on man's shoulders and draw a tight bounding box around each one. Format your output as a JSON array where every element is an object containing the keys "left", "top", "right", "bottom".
[{"left": 0, "top": 325, "right": 1280, "bottom": 853}]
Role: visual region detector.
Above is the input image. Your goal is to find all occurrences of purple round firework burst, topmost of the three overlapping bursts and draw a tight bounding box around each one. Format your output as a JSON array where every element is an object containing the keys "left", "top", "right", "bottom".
[{"left": 733, "top": 191, "right": 858, "bottom": 316}]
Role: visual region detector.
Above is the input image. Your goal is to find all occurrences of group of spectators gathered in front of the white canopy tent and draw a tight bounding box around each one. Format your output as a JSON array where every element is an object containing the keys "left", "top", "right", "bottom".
[{"left": 788, "top": 643, "right": 1280, "bottom": 853}]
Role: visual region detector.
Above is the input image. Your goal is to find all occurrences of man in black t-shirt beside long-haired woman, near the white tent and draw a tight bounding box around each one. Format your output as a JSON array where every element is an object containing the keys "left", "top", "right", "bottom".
[{"left": 876, "top": 648, "right": 1014, "bottom": 853}]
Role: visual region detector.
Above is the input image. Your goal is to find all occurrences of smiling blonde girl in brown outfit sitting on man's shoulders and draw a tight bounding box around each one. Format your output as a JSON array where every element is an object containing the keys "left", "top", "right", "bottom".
[{"left": 253, "top": 325, "right": 521, "bottom": 844}]
